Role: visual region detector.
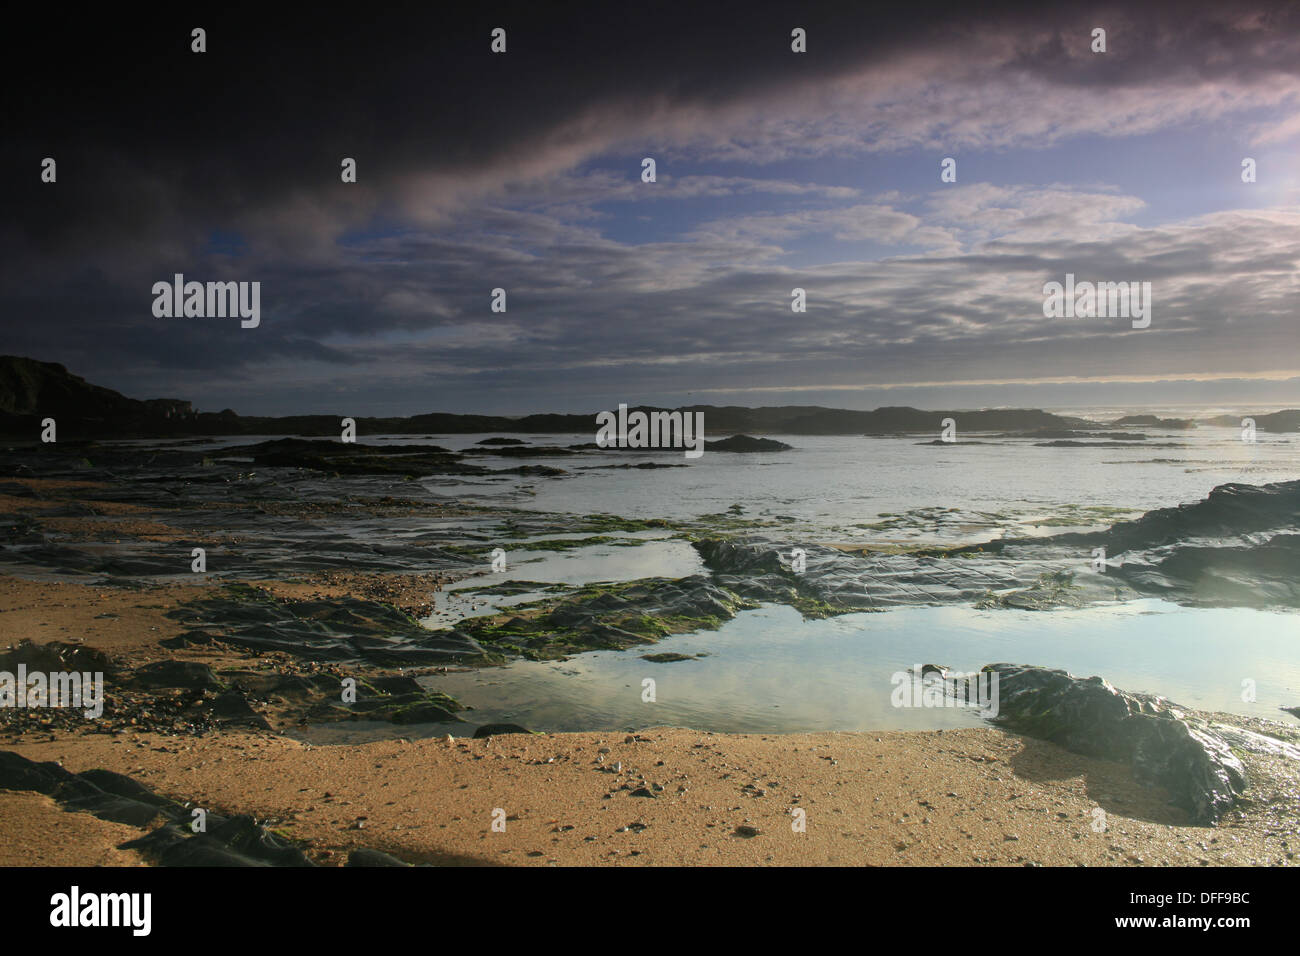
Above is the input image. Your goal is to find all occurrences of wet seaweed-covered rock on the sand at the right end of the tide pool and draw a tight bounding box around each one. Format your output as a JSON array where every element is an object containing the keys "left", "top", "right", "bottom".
[{"left": 984, "top": 663, "right": 1247, "bottom": 825}]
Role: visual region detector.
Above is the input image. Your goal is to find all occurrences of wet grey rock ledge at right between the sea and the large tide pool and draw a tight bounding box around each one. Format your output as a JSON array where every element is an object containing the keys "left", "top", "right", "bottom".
[{"left": 694, "top": 481, "right": 1300, "bottom": 611}]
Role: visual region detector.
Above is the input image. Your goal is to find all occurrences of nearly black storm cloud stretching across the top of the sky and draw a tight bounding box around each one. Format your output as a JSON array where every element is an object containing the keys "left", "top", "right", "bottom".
[{"left": 5, "top": 3, "right": 1300, "bottom": 255}]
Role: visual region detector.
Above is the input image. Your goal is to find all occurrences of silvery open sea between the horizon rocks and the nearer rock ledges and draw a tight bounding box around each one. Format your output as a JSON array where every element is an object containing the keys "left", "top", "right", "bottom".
[{"left": 421, "top": 421, "right": 1296, "bottom": 538}]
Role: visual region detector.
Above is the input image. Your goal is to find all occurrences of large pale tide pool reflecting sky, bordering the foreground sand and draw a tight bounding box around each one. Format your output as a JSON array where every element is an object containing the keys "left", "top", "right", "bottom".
[{"left": 292, "top": 600, "right": 1300, "bottom": 743}]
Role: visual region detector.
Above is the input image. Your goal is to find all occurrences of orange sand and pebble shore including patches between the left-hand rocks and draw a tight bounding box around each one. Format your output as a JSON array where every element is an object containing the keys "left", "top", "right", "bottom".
[{"left": 0, "top": 468, "right": 1300, "bottom": 866}]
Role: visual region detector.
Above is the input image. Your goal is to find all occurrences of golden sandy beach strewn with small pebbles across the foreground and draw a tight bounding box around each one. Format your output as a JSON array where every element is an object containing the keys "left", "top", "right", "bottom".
[{"left": 0, "top": 576, "right": 1297, "bottom": 866}]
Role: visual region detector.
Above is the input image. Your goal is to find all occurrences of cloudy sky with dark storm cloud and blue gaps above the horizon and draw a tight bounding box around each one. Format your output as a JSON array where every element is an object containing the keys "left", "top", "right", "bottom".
[{"left": 0, "top": 0, "right": 1300, "bottom": 415}]
